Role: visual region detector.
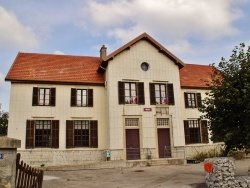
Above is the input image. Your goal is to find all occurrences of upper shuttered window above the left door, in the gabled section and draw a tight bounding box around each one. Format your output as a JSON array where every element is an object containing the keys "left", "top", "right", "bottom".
[{"left": 118, "top": 82, "right": 145, "bottom": 104}]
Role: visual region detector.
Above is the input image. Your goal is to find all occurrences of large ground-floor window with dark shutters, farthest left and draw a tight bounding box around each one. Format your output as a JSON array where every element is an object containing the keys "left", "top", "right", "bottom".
[{"left": 26, "top": 120, "right": 59, "bottom": 148}]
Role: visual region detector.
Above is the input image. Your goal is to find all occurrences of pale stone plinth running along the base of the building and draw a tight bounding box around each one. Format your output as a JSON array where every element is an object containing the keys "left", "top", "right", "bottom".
[{"left": 15, "top": 144, "right": 227, "bottom": 166}]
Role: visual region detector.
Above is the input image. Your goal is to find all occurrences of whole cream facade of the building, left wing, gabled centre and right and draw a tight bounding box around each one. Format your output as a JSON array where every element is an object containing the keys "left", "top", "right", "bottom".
[{"left": 5, "top": 33, "right": 222, "bottom": 165}]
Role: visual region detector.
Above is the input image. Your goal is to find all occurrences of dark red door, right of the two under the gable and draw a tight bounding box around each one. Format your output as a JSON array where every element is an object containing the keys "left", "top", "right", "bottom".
[{"left": 157, "top": 129, "right": 171, "bottom": 158}]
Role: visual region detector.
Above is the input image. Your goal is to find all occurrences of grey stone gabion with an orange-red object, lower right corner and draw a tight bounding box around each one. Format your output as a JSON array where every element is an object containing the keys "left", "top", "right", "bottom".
[{"left": 204, "top": 157, "right": 250, "bottom": 188}]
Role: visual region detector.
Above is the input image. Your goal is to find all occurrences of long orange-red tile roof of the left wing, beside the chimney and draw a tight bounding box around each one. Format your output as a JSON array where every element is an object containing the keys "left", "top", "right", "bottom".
[{"left": 5, "top": 53, "right": 104, "bottom": 84}]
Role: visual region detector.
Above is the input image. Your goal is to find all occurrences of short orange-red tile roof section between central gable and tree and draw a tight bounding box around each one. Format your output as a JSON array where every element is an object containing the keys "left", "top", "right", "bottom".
[{"left": 180, "top": 64, "right": 214, "bottom": 88}]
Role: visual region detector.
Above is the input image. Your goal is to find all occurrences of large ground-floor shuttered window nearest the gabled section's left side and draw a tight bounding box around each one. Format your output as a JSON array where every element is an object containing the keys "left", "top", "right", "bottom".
[{"left": 66, "top": 120, "right": 98, "bottom": 148}]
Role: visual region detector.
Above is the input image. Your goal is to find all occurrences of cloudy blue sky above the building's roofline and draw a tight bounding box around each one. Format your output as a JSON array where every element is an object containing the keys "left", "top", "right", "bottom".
[{"left": 0, "top": 0, "right": 250, "bottom": 111}]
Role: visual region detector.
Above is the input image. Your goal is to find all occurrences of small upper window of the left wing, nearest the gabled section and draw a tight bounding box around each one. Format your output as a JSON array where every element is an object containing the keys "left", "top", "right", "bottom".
[{"left": 71, "top": 88, "right": 93, "bottom": 107}]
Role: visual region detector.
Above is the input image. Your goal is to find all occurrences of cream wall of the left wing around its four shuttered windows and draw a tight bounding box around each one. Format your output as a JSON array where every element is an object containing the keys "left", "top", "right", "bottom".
[{"left": 8, "top": 83, "right": 107, "bottom": 150}]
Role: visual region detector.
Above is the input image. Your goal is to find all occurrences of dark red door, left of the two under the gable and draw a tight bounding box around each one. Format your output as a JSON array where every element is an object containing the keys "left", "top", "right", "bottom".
[{"left": 126, "top": 129, "right": 140, "bottom": 160}]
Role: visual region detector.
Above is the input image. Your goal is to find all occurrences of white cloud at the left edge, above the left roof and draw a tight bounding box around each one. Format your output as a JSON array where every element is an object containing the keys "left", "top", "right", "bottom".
[{"left": 0, "top": 6, "right": 39, "bottom": 49}]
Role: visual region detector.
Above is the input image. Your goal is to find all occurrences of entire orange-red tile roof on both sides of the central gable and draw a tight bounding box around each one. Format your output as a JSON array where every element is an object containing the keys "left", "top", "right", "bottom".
[{"left": 5, "top": 53, "right": 213, "bottom": 88}]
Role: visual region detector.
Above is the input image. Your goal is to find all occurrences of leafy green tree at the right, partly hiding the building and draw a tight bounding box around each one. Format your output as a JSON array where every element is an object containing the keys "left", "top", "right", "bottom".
[{"left": 200, "top": 43, "right": 250, "bottom": 155}]
